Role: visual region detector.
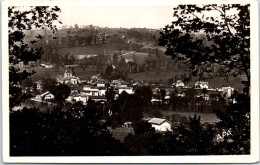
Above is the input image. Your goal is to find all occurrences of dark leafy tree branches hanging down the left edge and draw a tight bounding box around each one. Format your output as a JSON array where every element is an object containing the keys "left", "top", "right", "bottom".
[{"left": 8, "top": 6, "right": 61, "bottom": 110}]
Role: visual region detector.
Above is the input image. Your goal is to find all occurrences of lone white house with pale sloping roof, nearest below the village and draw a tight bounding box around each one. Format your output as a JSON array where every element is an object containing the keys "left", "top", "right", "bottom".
[{"left": 148, "top": 118, "right": 172, "bottom": 132}]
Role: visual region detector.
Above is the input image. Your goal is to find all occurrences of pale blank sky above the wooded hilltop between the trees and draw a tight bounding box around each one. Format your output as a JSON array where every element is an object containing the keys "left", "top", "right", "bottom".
[{"left": 59, "top": 5, "right": 176, "bottom": 29}]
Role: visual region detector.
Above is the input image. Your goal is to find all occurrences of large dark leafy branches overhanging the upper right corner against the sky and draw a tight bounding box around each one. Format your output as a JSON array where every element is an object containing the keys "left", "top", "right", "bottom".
[{"left": 159, "top": 4, "right": 250, "bottom": 92}]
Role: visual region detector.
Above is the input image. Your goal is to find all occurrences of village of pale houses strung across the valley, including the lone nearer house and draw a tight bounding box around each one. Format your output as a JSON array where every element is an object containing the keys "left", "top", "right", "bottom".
[{"left": 16, "top": 66, "right": 235, "bottom": 140}]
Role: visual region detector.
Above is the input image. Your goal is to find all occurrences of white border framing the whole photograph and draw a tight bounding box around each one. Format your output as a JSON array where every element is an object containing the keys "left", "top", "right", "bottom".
[{"left": 1, "top": 0, "right": 259, "bottom": 163}]
